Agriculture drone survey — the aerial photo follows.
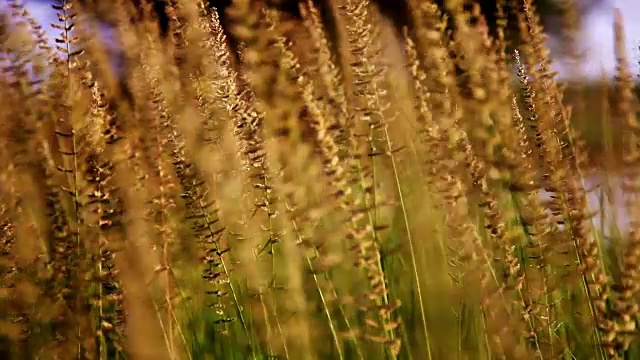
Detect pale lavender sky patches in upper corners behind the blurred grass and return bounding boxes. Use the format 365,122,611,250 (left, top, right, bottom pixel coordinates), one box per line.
7,0,640,80
